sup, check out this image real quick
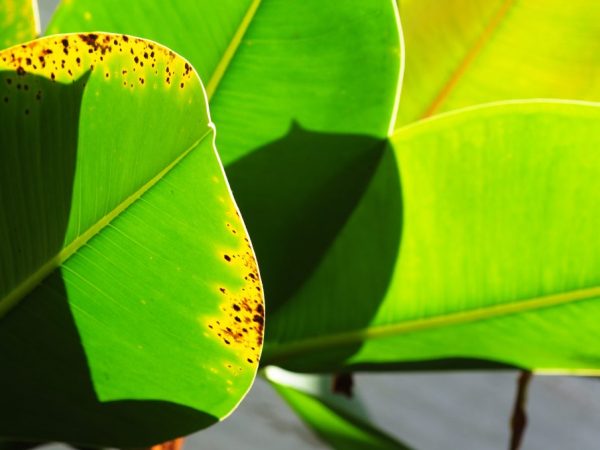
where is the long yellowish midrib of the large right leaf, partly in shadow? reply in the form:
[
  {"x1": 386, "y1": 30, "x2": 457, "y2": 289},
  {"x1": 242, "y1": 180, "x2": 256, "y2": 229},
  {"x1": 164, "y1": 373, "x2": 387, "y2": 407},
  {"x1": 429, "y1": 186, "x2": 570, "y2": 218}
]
[{"x1": 263, "y1": 286, "x2": 600, "y2": 364}]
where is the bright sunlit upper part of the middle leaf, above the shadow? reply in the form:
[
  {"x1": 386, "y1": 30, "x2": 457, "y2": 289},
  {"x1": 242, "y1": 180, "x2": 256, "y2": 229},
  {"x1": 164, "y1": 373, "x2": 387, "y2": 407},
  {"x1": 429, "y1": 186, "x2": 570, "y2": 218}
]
[{"x1": 48, "y1": 0, "x2": 401, "y2": 162}]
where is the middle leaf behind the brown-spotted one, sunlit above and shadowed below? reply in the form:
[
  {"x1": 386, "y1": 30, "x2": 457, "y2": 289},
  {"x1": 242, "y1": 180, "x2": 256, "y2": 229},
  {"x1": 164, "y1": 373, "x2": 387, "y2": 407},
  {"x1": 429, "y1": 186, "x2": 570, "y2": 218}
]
[{"x1": 49, "y1": 0, "x2": 401, "y2": 344}]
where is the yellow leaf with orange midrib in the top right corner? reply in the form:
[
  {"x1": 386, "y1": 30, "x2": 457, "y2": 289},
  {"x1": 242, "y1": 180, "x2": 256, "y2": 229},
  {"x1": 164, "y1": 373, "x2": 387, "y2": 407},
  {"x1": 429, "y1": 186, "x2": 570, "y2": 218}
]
[{"x1": 397, "y1": 0, "x2": 600, "y2": 126}]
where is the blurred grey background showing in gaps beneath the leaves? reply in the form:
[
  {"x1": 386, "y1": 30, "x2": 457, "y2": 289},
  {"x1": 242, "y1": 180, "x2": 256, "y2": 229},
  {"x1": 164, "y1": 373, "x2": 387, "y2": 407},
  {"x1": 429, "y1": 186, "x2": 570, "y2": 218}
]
[{"x1": 39, "y1": 0, "x2": 600, "y2": 450}]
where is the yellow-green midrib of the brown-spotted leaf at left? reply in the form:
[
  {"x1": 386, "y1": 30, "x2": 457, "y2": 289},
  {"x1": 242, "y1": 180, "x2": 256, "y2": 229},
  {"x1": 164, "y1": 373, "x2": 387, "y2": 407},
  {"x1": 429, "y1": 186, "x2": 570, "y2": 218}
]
[{"x1": 0, "y1": 125, "x2": 213, "y2": 318}]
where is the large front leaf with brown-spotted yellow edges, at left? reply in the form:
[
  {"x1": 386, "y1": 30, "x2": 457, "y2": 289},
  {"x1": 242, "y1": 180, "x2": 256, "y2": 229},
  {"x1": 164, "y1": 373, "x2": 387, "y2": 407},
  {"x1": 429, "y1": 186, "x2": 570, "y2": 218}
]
[{"x1": 0, "y1": 34, "x2": 263, "y2": 447}]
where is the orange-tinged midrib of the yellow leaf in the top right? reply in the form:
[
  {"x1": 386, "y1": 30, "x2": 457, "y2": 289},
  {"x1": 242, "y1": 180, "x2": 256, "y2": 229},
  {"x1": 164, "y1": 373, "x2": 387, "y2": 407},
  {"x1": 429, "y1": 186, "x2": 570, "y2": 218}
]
[{"x1": 421, "y1": 0, "x2": 515, "y2": 119}]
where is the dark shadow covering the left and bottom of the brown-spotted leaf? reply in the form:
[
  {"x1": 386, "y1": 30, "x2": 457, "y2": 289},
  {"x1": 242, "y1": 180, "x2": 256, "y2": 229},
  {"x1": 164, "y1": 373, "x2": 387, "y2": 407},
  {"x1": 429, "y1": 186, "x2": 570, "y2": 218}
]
[{"x1": 0, "y1": 72, "x2": 217, "y2": 447}]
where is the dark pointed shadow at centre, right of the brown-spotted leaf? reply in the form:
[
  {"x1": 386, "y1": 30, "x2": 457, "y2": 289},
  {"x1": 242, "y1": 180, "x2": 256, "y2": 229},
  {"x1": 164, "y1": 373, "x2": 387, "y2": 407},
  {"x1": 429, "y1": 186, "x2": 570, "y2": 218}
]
[{"x1": 226, "y1": 124, "x2": 402, "y2": 370}]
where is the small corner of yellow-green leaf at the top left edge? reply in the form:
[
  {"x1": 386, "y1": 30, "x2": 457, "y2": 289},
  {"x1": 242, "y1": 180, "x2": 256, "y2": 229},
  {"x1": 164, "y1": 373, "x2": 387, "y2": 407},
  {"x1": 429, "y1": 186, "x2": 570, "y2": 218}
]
[{"x1": 0, "y1": 0, "x2": 40, "y2": 50}]
